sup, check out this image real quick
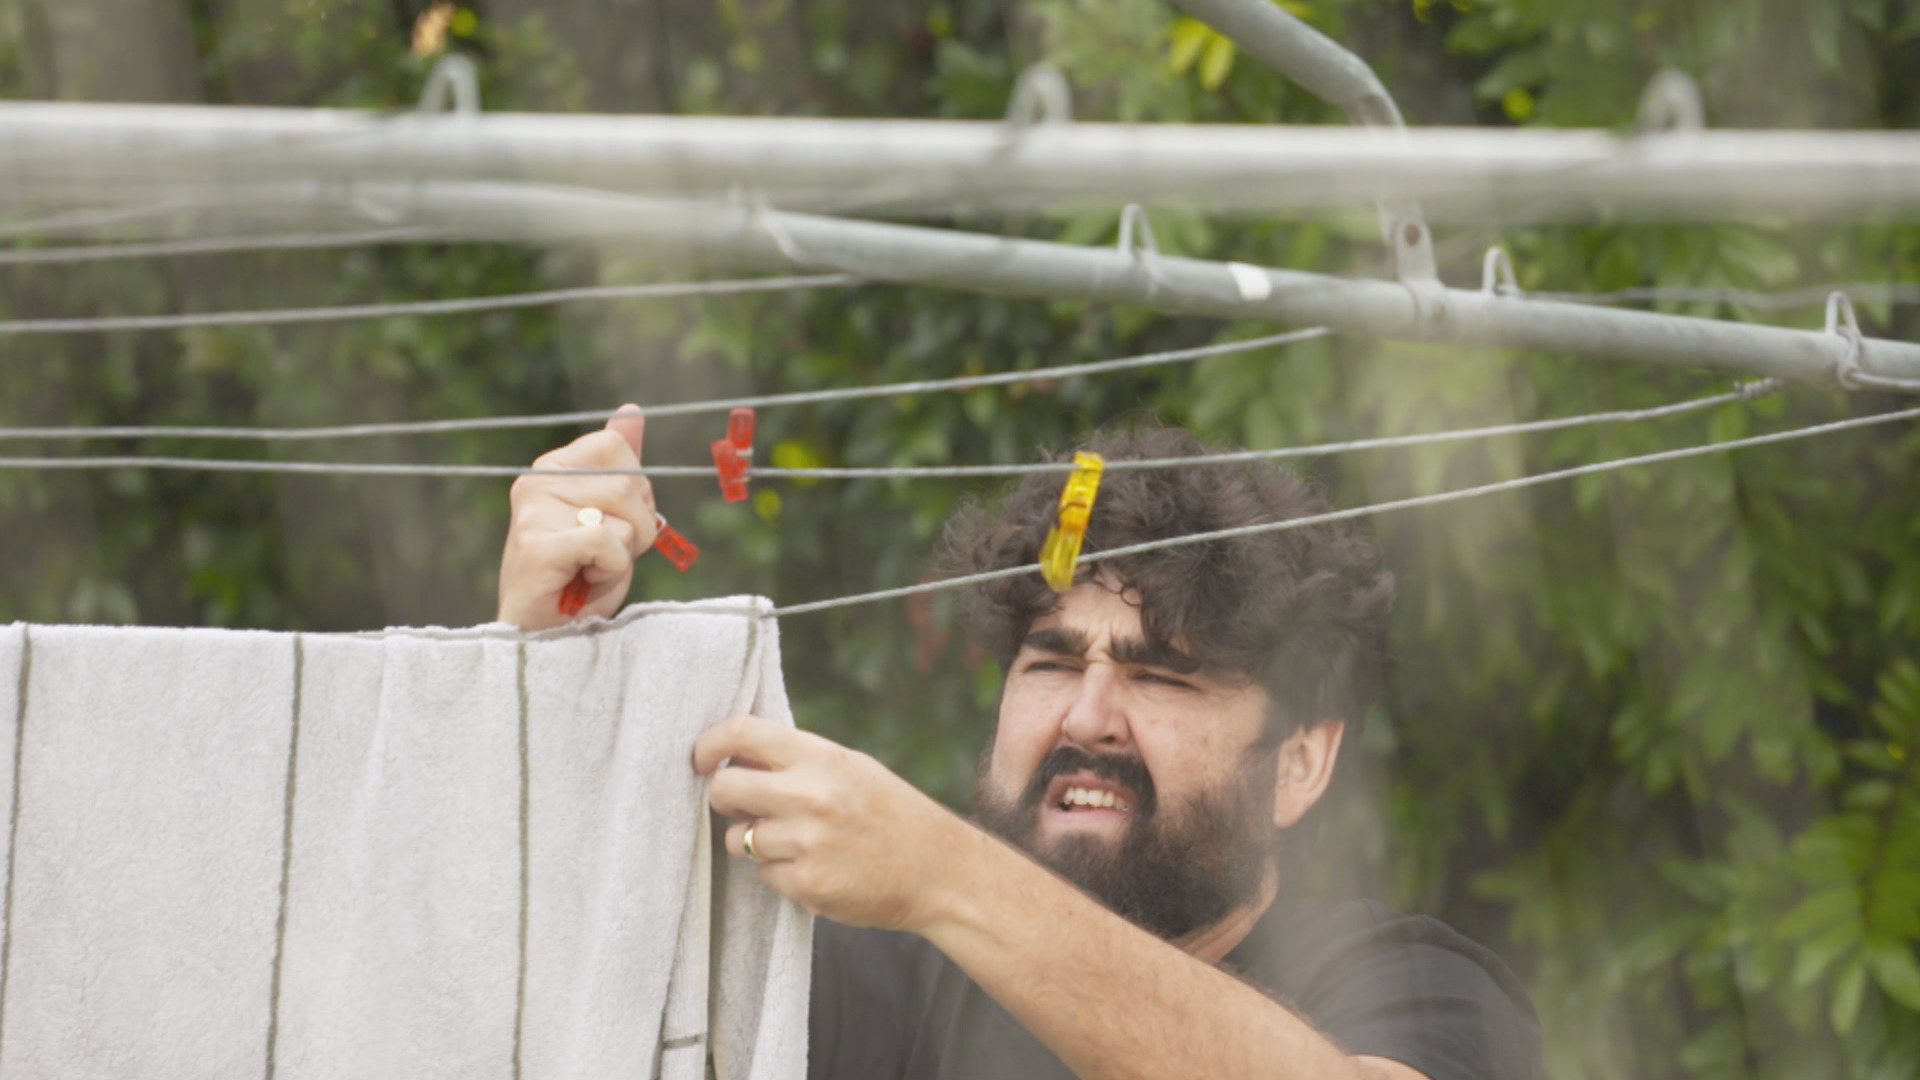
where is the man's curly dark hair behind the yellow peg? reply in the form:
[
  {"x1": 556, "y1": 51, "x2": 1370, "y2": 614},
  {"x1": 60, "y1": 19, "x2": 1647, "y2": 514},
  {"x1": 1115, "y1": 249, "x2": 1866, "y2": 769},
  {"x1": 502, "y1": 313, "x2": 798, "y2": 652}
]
[{"x1": 941, "y1": 419, "x2": 1394, "y2": 746}]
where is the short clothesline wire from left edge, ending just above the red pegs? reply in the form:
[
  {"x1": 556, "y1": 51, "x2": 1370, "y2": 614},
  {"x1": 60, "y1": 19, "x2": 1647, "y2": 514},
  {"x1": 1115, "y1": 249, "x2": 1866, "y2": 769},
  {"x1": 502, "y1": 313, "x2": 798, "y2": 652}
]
[{"x1": 0, "y1": 273, "x2": 860, "y2": 336}]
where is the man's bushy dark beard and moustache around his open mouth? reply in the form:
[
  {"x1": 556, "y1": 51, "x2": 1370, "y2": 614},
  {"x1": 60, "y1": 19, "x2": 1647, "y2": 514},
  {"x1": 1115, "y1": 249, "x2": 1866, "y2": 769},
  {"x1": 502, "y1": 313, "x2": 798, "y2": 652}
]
[{"x1": 973, "y1": 746, "x2": 1279, "y2": 940}]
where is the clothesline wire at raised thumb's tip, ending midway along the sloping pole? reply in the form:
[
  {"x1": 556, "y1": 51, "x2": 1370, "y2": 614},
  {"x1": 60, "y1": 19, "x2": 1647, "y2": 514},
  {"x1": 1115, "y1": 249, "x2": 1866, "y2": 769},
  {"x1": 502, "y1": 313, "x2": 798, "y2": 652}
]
[{"x1": 0, "y1": 326, "x2": 1332, "y2": 440}]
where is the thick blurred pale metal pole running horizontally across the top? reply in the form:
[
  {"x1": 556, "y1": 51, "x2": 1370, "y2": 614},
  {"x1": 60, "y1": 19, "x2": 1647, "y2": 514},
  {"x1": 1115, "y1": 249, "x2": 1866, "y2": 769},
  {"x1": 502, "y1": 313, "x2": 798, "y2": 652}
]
[{"x1": 0, "y1": 105, "x2": 1920, "y2": 222}]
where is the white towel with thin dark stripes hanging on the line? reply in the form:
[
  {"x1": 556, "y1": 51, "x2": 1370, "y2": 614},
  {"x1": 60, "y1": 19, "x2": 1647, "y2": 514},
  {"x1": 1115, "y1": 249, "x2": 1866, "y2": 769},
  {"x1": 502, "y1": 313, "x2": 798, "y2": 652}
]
[{"x1": 0, "y1": 598, "x2": 812, "y2": 1080}]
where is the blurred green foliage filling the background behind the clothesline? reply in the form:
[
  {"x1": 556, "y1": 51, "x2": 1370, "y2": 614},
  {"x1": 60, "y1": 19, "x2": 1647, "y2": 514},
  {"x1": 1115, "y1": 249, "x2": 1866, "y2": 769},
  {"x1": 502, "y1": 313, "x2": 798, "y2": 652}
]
[{"x1": 0, "y1": 0, "x2": 1920, "y2": 1080}]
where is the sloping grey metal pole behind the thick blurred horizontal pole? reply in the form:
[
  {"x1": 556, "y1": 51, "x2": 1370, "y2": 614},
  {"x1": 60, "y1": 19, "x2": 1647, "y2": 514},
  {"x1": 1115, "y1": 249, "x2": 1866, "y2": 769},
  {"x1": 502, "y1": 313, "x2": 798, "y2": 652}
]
[{"x1": 361, "y1": 184, "x2": 1920, "y2": 386}]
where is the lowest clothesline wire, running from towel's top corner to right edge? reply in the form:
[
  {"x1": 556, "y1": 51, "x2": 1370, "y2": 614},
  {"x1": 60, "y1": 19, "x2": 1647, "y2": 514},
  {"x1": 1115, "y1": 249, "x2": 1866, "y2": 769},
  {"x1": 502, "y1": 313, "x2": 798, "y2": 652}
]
[{"x1": 770, "y1": 399, "x2": 1920, "y2": 617}]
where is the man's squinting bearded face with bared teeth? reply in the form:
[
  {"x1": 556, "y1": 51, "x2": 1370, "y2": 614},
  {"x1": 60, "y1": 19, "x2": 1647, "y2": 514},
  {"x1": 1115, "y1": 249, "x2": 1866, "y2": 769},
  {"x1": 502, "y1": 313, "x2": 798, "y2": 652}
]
[{"x1": 975, "y1": 578, "x2": 1275, "y2": 938}]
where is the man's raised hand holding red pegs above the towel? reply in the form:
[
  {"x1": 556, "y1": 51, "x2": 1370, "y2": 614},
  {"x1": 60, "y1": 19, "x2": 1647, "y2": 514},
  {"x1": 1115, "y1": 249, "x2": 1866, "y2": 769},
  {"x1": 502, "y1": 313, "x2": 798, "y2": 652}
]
[{"x1": 497, "y1": 405, "x2": 659, "y2": 630}]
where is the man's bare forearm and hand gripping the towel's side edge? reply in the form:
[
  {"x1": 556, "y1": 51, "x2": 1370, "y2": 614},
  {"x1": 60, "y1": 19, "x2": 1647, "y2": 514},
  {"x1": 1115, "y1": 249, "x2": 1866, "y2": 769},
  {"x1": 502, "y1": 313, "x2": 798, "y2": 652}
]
[{"x1": 695, "y1": 717, "x2": 1423, "y2": 1080}]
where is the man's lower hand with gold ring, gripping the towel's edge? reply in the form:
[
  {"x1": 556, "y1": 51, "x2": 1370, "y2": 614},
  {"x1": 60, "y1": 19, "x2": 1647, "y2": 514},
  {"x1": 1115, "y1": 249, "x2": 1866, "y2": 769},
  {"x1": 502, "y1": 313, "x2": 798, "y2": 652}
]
[{"x1": 693, "y1": 717, "x2": 975, "y2": 932}]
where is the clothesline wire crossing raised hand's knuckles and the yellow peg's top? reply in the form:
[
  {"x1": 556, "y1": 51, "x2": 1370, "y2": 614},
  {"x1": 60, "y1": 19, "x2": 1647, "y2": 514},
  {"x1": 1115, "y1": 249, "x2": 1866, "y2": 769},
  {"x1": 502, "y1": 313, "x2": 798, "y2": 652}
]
[{"x1": 0, "y1": 379, "x2": 1780, "y2": 480}]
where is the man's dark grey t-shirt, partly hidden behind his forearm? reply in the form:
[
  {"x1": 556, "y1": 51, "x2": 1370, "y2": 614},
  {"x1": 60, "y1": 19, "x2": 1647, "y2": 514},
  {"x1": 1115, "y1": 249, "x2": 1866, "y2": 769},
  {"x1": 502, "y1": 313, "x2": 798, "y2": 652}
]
[{"x1": 806, "y1": 899, "x2": 1540, "y2": 1080}]
